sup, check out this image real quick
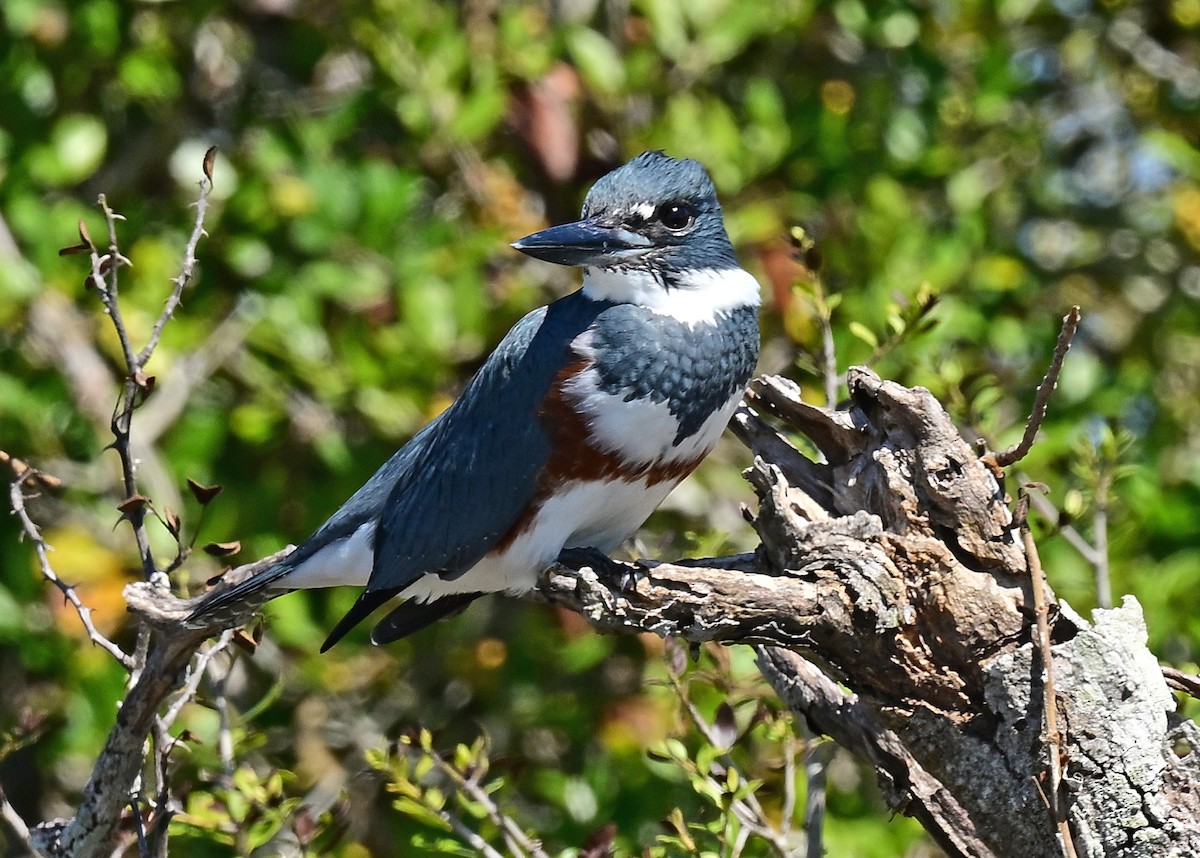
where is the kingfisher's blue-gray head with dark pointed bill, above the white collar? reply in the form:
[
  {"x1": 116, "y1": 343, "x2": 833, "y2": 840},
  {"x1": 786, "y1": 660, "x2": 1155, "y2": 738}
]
[{"x1": 512, "y1": 151, "x2": 738, "y2": 277}]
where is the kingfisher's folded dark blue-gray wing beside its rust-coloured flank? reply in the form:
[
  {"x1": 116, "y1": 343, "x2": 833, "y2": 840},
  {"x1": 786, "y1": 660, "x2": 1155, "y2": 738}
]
[{"x1": 364, "y1": 293, "x2": 608, "y2": 593}]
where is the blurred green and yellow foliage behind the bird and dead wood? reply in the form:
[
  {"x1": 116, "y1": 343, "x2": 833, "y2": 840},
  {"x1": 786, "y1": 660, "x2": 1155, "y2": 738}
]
[{"x1": 0, "y1": 0, "x2": 1200, "y2": 857}]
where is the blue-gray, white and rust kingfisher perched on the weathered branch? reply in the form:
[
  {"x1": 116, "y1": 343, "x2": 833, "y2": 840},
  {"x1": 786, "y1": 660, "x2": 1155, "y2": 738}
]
[{"x1": 190, "y1": 151, "x2": 760, "y2": 652}]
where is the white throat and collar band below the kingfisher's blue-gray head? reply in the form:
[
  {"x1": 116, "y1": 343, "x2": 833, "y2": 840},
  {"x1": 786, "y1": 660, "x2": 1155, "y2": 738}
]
[{"x1": 583, "y1": 268, "x2": 761, "y2": 324}]
